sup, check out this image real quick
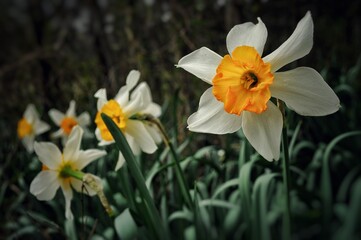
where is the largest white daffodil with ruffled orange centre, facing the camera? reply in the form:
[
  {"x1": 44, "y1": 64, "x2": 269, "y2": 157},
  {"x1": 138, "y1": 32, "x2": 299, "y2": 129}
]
[{"x1": 177, "y1": 12, "x2": 340, "y2": 161}]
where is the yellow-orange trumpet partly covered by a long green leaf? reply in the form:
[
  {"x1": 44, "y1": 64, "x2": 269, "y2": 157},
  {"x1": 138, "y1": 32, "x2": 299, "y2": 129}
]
[{"x1": 95, "y1": 100, "x2": 127, "y2": 141}]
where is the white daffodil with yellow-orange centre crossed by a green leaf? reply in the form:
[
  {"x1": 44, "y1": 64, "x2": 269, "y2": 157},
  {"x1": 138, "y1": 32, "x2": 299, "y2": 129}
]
[{"x1": 94, "y1": 70, "x2": 161, "y2": 170}]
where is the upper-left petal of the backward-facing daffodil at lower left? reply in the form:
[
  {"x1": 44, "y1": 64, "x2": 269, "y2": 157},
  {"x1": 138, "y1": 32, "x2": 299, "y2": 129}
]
[{"x1": 34, "y1": 142, "x2": 62, "y2": 169}]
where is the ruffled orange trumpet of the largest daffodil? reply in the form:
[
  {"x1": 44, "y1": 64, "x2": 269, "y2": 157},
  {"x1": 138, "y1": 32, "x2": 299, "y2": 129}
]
[{"x1": 212, "y1": 46, "x2": 274, "y2": 115}]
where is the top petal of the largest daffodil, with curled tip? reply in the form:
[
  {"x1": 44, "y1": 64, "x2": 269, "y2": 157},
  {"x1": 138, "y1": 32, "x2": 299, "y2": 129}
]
[{"x1": 226, "y1": 18, "x2": 267, "y2": 56}]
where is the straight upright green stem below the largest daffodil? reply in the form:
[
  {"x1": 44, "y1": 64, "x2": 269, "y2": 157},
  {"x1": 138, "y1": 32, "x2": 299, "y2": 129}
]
[{"x1": 278, "y1": 101, "x2": 291, "y2": 240}]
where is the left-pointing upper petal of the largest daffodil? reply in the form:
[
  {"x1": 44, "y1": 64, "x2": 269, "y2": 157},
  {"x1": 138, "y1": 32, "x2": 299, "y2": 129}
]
[{"x1": 176, "y1": 47, "x2": 222, "y2": 84}]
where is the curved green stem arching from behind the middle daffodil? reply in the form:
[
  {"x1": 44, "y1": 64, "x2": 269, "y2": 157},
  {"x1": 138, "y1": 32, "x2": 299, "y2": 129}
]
[{"x1": 145, "y1": 115, "x2": 194, "y2": 210}]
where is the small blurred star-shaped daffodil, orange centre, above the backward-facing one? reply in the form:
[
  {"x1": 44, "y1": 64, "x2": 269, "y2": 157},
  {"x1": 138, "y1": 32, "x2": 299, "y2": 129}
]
[{"x1": 49, "y1": 100, "x2": 90, "y2": 144}]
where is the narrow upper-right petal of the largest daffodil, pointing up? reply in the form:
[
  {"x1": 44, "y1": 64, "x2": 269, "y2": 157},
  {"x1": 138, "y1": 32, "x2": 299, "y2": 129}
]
[{"x1": 263, "y1": 12, "x2": 313, "y2": 72}]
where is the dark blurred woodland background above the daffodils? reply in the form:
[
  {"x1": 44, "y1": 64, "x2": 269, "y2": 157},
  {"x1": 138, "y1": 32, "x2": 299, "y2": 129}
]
[{"x1": 0, "y1": 0, "x2": 361, "y2": 133}]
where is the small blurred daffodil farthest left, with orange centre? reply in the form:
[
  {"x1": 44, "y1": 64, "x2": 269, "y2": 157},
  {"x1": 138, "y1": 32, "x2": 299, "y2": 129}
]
[{"x1": 17, "y1": 104, "x2": 50, "y2": 153}]
